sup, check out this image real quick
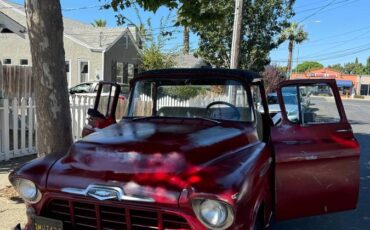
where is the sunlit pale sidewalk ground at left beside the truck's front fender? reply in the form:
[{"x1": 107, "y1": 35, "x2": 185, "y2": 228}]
[{"x1": 0, "y1": 155, "x2": 36, "y2": 230}]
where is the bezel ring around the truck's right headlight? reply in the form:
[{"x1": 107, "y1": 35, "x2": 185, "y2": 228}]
[{"x1": 191, "y1": 198, "x2": 234, "y2": 230}]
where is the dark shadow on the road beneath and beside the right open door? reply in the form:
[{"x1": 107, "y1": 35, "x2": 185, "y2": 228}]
[{"x1": 269, "y1": 133, "x2": 370, "y2": 230}]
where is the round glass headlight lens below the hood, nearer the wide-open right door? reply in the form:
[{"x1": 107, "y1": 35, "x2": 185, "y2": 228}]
[{"x1": 199, "y1": 200, "x2": 227, "y2": 226}]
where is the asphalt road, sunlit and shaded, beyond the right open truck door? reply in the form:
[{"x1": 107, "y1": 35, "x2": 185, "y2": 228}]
[{"x1": 269, "y1": 100, "x2": 370, "y2": 230}]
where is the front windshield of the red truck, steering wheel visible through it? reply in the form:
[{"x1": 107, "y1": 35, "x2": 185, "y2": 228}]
[{"x1": 128, "y1": 78, "x2": 253, "y2": 121}]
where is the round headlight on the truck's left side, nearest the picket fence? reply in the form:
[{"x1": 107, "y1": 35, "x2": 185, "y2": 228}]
[{"x1": 13, "y1": 179, "x2": 41, "y2": 204}]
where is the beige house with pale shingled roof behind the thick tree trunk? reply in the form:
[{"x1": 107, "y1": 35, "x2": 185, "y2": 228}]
[{"x1": 0, "y1": 0, "x2": 141, "y2": 86}]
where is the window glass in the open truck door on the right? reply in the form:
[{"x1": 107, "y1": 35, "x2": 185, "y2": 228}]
[{"x1": 282, "y1": 84, "x2": 340, "y2": 124}]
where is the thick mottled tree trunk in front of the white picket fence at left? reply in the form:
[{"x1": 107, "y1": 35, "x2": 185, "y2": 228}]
[{"x1": 26, "y1": 0, "x2": 73, "y2": 156}]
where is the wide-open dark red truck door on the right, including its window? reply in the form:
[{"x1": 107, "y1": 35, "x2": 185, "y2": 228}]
[{"x1": 271, "y1": 79, "x2": 360, "y2": 220}]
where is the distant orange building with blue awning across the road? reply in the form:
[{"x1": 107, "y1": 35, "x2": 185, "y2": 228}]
[{"x1": 291, "y1": 68, "x2": 360, "y2": 95}]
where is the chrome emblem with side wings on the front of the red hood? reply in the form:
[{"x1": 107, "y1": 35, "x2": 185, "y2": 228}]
[{"x1": 61, "y1": 184, "x2": 155, "y2": 202}]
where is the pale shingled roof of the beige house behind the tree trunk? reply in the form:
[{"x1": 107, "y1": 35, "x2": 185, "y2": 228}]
[{"x1": 0, "y1": 0, "x2": 138, "y2": 51}]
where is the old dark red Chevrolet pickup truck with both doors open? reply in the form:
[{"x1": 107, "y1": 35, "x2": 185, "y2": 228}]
[{"x1": 9, "y1": 69, "x2": 360, "y2": 230}]
